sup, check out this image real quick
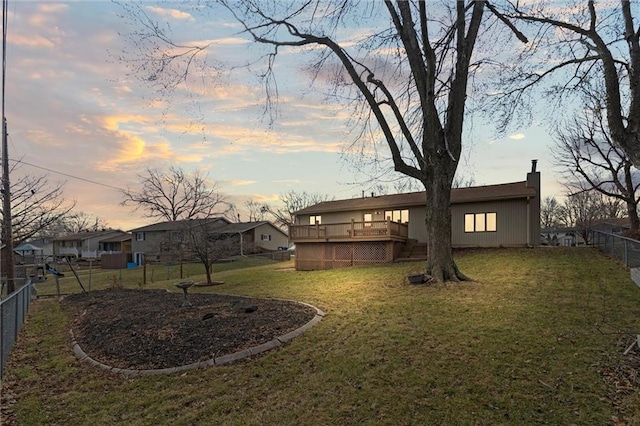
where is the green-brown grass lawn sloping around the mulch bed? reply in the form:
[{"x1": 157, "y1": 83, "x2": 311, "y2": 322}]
[{"x1": 3, "y1": 248, "x2": 640, "y2": 425}]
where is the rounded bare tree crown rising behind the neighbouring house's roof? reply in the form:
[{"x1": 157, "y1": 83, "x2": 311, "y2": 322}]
[{"x1": 122, "y1": 166, "x2": 230, "y2": 221}]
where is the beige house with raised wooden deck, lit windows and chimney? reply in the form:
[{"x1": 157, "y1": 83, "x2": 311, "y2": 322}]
[{"x1": 289, "y1": 160, "x2": 540, "y2": 270}]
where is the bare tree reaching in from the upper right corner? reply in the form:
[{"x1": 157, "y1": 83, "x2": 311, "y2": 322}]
[{"x1": 493, "y1": 0, "x2": 640, "y2": 167}]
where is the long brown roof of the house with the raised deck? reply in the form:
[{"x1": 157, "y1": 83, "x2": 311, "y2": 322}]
[{"x1": 295, "y1": 181, "x2": 536, "y2": 215}]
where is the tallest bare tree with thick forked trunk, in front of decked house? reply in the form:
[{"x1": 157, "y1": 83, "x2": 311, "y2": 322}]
[{"x1": 119, "y1": 0, "x2": 524, "y2": 281}]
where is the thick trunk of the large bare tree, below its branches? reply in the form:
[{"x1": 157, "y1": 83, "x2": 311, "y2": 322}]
[{"x1": 423, "y1": 166, "x2": 469, "y2": 282}]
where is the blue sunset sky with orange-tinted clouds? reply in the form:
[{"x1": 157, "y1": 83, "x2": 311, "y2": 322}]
[{"x1": 5, "y1": 0, "x2": 564, "y2": 230}]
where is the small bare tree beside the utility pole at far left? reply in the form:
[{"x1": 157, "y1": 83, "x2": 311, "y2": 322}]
[{"x1": 0, "y1": 169, "x2": 75, "y2": 244}]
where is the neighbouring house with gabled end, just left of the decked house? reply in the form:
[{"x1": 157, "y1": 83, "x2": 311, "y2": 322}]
[{"x1": 131, "y1": 217, "x2": 289, "y2": 265}]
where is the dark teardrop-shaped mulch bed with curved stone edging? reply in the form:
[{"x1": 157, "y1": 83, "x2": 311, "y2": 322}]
[{"x1": 62, "y1": 289, "x2": 316, "y2": 369}]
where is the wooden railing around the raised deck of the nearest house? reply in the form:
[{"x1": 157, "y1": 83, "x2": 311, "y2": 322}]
[{"x1": 289, "y1": 220, "x2": 409, "y2": 242}]
